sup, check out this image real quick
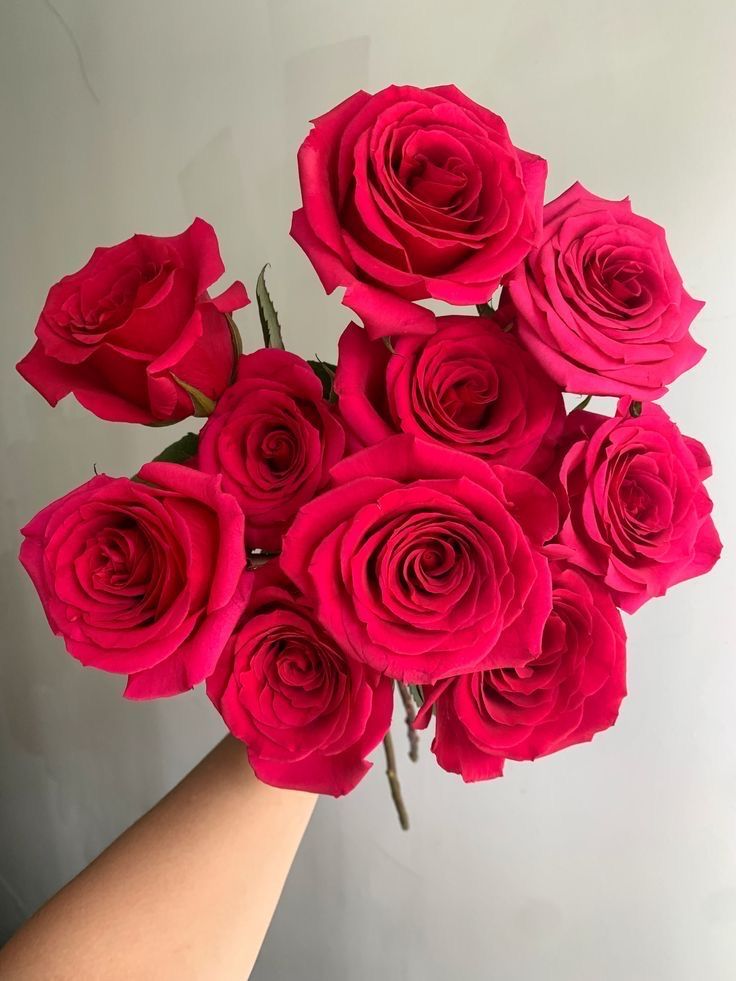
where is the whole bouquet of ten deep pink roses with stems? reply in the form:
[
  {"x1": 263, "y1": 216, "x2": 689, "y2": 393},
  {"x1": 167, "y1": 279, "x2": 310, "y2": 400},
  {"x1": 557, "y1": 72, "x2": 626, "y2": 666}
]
[{"x1": 18, "y1": 86, "x2": 721, "y2": 825}]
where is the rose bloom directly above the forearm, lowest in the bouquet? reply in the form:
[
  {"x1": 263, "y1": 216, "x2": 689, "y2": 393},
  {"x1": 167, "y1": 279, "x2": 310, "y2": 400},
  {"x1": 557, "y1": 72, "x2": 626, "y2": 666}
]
[{"x1": 207, "y1": 561, "x2": 393, "y2": 797}]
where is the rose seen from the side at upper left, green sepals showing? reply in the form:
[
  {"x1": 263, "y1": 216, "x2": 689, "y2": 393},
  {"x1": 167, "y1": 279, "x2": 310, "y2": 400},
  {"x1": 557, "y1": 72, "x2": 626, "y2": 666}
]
[{"x1": 18, "y1": 218, "x2": 248, "y2": 424}]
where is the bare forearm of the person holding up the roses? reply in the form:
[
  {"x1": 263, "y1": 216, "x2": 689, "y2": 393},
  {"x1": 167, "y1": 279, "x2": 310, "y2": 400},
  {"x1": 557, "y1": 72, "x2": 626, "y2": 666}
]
[{"x1": 0, "y1": 736, "x2": 317, "y2": 981}]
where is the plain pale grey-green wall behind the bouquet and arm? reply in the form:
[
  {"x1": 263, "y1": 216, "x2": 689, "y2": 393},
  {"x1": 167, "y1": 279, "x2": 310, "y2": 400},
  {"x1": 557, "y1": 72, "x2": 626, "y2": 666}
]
[{"x1": 0, "y1": 0, "x2": 736, "y2": 981}]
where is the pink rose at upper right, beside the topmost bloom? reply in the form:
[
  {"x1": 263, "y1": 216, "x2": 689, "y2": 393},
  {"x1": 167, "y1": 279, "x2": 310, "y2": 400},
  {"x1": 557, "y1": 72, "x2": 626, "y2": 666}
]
[{"x1": 501, "y1": 184, "x2": 705, "y2": 399}]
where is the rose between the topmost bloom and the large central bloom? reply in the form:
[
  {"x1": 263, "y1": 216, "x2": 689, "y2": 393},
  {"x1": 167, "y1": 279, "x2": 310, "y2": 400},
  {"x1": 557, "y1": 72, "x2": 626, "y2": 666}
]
[{"x1": 334, "y1": 317, "x2": 565, "y2": 467}]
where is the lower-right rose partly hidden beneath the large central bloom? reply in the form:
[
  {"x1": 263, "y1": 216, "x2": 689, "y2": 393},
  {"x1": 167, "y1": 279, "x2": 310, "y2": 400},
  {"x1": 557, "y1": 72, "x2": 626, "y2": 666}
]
[{"x1": 416, "y1": 563, "x2": 626, "y2": 782}]
